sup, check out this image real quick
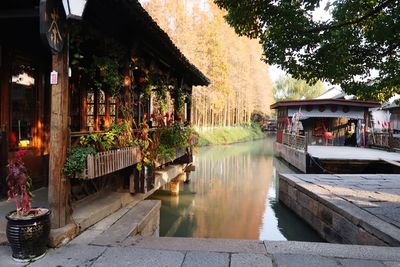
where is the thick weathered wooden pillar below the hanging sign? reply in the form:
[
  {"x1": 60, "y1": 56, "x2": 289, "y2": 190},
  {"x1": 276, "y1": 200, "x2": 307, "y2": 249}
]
[{"x1": 48, "y1": 48, "x2": 71, "y2": 229}]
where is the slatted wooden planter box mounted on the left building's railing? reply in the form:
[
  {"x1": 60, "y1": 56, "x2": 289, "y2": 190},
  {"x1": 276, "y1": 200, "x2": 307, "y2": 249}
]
[{"x1": 75, "y1": 147, "x2": 140, "y2": 179}]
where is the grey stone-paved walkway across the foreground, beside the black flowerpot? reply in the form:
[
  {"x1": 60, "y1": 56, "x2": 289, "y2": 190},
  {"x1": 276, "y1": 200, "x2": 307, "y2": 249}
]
[{"x1": 0, "y1": 236, "x2": 400, "y2": 267}]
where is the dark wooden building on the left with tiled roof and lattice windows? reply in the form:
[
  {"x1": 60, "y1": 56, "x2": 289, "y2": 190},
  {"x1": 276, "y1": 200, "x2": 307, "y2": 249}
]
[{"x1": 0, "y1": 0, "x2": 209, "y2": 234}]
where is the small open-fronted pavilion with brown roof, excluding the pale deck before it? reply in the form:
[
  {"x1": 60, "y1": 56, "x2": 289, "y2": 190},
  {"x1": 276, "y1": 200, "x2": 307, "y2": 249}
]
[{"x1": 271, "y1": 99, "x2": 380, "y2": 146}]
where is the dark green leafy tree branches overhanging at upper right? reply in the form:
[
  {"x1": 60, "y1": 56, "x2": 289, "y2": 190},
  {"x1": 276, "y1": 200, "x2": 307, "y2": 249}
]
[{"x1": 214, "y1": 0, "x2": 400, "y2": 101}]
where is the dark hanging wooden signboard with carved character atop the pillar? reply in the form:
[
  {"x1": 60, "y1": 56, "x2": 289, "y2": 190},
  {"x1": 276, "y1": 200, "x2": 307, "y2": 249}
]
[{"x1": 40, "y1": 0, "x2": 66, "y2": 53}]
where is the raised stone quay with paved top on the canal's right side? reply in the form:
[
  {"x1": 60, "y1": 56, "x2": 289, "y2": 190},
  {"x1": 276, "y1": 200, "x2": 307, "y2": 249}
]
[{"x1": 279, "y1": 174, "x2": 400, "y2": 246}]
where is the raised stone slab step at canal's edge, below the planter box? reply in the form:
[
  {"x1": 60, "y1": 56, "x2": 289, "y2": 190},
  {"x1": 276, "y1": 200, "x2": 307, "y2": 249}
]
[{"x1": 90, "y1": 200, "x2": 161, "y2": 246}]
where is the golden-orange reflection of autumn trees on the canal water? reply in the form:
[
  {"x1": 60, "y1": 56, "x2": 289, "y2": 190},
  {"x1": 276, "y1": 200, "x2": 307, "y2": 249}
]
[{"x1": 189, "y1": 141, "x2": 272, "y2": 239}]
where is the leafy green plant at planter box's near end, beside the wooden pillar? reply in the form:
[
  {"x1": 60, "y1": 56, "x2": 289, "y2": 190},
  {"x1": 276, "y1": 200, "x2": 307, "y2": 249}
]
[{"x1": 63, "y1": 146, "x2": 96, "y2": 177}]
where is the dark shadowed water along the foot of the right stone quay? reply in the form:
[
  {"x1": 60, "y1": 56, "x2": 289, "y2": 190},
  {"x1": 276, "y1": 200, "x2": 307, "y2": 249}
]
[{"x1": 270, "y1": 200, "x2": 324, "y2": 242}]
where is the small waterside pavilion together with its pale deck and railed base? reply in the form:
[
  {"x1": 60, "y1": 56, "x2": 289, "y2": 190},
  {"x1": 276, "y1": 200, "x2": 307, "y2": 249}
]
[{"x1": 271, "y1": 99, "x2": 400, "y2": 173}]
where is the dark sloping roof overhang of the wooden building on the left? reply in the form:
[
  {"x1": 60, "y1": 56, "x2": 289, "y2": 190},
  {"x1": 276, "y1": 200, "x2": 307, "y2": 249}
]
[{"x1": 83, "y1": 0, "x2": 210, "y2": 86}]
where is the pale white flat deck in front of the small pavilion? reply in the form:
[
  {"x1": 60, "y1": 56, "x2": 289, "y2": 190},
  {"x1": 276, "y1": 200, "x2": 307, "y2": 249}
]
[{"x1": 307, "y1": 146, "x2": 400, "y2": 161}]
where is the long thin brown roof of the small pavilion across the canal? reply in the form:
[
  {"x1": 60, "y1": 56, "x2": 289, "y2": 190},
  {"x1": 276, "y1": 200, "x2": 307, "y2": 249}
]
[{"x1": 271, "y1": 99, "x2": 381, "y2": 109}]
